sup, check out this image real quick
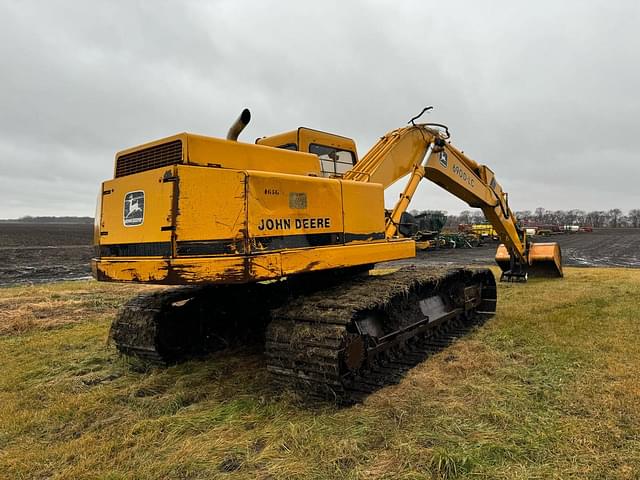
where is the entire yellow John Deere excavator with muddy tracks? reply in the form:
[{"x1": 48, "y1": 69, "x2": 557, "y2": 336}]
[{"x1": 92, "y1": 109, "x2": 562, "y2": 402}]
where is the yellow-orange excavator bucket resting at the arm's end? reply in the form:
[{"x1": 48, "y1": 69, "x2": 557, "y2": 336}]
[{"x1": 496, "y1": 242, "x2": 563, "y2": 281}]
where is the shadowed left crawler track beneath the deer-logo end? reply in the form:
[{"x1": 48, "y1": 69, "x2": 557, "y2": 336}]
[{"x1": 110, "y1": 284, "x2": 286, "y2": 364}]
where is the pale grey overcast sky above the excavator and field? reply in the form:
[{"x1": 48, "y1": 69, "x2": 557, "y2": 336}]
[{"x1": 0, "y1": 0, "x2": 640, "y2": 218}]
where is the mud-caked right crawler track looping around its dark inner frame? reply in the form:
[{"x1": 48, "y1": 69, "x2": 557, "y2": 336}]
[{"x1": 265, "y1": 268, "x2": 496, "y2": 404}]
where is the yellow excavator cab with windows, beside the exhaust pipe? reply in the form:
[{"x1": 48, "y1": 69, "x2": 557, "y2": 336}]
[{"x1": 256, "y1": 127, "x2": 358, "y2": 178}]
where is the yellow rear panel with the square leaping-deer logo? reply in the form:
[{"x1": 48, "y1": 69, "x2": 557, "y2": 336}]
[{"x1": 100, "y1": 167, "x2": 173, "y2": 245}]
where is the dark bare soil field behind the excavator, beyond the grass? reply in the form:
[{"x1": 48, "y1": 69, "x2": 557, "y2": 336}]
[{"x1": 0, "y1": 223, "x2": 640, "y2": 286}]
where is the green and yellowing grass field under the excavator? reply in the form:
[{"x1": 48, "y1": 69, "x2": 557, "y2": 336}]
[{"x1": 0, "y1": 268, "x2": 640, "y2": 479}]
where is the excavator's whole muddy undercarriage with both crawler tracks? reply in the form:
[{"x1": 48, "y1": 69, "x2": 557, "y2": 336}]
[{"x1": 111, "y1": 267, "x2": 496, "y2": 403}]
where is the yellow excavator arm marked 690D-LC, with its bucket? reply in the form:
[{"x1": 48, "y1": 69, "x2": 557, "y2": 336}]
[{"x1": 344, "y1": 124, "x2": 562, "y2": 280}]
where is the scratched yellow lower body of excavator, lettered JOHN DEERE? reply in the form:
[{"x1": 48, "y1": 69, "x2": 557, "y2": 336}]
[{"x1": 93, "y1": 164, "x2": 415, "y2": 285}]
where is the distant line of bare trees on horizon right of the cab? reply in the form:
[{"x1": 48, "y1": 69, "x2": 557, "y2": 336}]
[{"x1": 411, "y1": 207, "x2": 640, "y2": 228}]
